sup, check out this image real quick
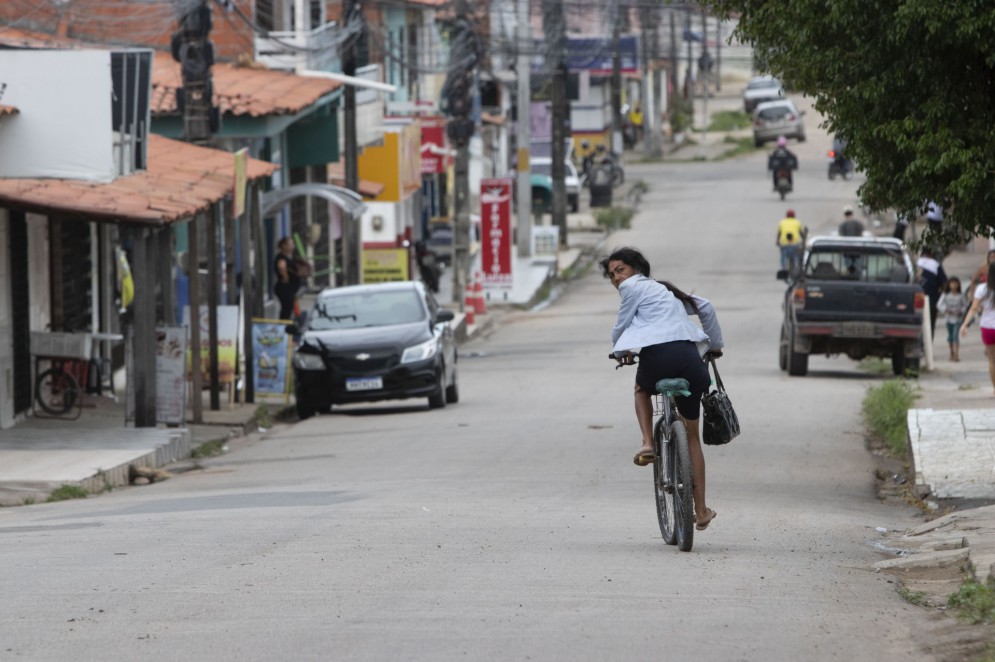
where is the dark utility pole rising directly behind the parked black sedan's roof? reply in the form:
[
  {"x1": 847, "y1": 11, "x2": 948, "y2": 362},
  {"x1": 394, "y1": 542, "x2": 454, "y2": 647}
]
[{"x1": 342, "y1": 0, "x2": 363, "y2": 285}]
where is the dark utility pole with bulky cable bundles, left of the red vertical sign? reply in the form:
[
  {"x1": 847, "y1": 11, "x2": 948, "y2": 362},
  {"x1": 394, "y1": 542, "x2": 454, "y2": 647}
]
[{"x1": 442, "y1": 0, "x2": 480, "y2": 310}]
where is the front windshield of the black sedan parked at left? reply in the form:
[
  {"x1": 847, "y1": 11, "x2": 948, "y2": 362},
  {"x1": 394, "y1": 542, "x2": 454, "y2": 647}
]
[{"x1": 308, "y1": 290, "x2": 425, "y2": 331}]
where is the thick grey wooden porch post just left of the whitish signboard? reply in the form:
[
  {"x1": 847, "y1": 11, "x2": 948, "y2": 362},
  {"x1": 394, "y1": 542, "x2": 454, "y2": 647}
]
[{"x1": 131, "y1": 229, "x2": 158, "y2": 428}]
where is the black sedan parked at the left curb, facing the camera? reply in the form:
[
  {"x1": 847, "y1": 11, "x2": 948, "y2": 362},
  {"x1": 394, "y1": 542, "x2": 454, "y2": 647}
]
[{"x1": 294, "y1": 281, "x2": 459, "y2": 419}]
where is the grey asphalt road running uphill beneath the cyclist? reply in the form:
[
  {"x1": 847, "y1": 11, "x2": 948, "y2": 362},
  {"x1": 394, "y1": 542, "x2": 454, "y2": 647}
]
[{"x1": 0, "y1": 101, "x2": 944, "y2": 661}]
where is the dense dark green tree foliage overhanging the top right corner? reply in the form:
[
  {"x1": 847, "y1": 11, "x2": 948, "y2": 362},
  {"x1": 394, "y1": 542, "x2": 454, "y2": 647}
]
[{"x1": 706, "y1": 0, "x2": 995, "y2": 244}]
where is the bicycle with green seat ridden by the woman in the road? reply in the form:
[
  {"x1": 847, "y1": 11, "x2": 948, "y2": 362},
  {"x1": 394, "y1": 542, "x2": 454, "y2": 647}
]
[{"x1": 608, "y1": 354, "x2": 694, "y2": 552}]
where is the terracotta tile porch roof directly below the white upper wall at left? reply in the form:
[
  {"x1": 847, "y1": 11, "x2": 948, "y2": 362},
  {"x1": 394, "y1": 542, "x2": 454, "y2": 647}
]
[{"x1": 0, "y1": 135, "x2": 277, "y2": 225}]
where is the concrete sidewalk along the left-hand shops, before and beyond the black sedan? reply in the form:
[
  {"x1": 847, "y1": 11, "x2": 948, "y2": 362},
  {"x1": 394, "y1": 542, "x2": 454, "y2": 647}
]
[{"x1": 0, "y1": 213, "x2": 604, "y2": 506}]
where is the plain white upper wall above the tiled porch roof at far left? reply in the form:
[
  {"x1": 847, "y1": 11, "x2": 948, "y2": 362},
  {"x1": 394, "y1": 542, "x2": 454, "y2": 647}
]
[{"x1": 0, "y1": 50, "x2": 115, "y2": 182}]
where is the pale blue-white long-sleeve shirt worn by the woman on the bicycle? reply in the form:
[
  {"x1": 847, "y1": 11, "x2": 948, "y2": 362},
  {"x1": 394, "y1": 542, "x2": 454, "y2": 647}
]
[{"x1": 612, "y1": 274, "x2": 723, "y2": 354}]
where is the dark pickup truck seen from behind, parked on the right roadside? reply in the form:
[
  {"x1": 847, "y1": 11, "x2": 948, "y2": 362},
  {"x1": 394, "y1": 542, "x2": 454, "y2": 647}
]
[{"x1": 778, "y1": 237, "x2": 926, "y2": 376}]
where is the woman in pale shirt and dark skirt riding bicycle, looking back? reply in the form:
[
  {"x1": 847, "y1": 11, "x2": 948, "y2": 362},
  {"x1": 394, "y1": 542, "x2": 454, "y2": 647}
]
[{"x1": 601, "y1": 248, "x2": 723, "y2": 530}]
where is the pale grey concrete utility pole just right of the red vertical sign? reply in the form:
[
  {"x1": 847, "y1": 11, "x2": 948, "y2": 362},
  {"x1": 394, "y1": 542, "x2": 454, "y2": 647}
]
[{"x1": 515, "y1": 0, "x2": 532, "y2": 257}]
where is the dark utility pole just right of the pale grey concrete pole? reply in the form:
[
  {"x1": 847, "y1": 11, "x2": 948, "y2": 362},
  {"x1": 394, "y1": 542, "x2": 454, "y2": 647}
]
[{"x1": 543, "y1": 0, "x2": 570, "y2": 246}]
